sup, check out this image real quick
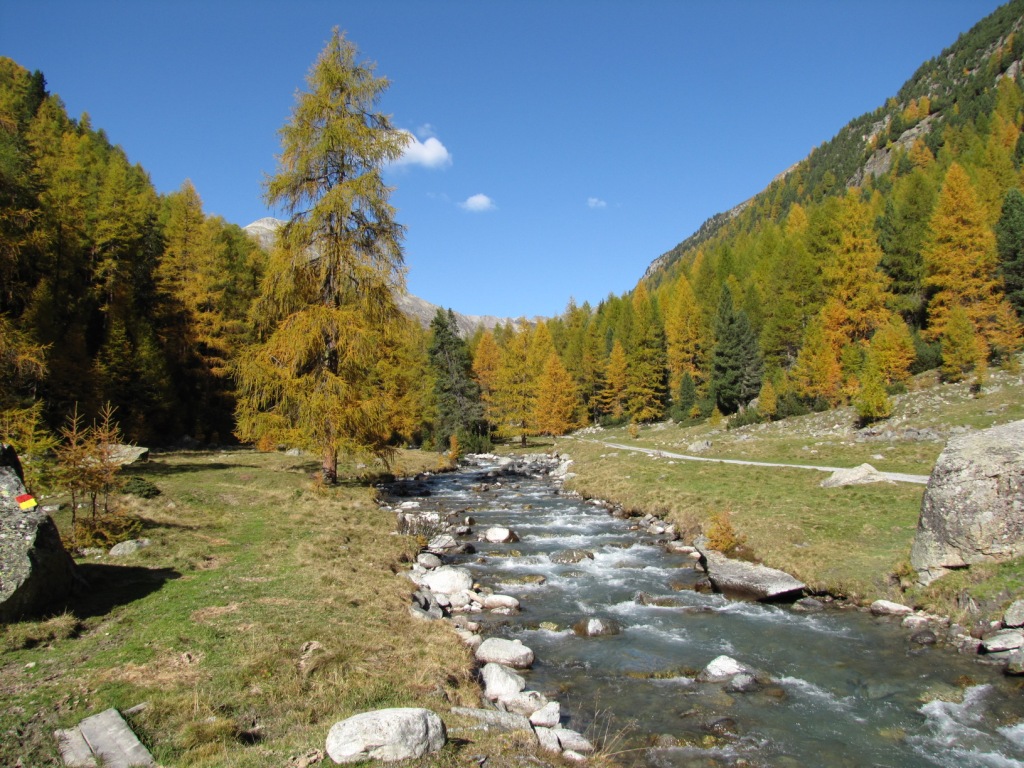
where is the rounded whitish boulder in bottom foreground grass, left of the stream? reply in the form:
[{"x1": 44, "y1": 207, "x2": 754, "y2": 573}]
[{"x1": 327, "y1": 708, "x2": 447, "y2": 763}]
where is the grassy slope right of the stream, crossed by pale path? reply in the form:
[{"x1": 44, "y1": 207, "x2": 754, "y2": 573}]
[{"x1": 553, "y1": 372, "x2": 1024, "y2": 618}]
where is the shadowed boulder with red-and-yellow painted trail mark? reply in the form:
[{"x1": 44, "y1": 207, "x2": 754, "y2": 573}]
[{"x1": 0, "y1": 466, "x2": 75, "y2": 622}]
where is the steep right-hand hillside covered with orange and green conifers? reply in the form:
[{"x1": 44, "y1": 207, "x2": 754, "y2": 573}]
[{"x1": 506, "y1": 0, "x2": 1024, "y2": 434}]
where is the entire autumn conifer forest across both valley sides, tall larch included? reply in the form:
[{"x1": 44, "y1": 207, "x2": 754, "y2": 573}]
[{"x1": 6, "y1": 0, "x2": 1024, "y2": 473}]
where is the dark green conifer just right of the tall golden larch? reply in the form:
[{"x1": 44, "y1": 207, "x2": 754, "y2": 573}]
[{"x1": 427, "y1": 309, "x2": 483, "y2": 452}]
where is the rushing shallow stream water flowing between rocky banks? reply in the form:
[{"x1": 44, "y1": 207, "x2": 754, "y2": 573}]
[{"x1": 391, "y1": 456, "x2": 1024, "y2": 768}]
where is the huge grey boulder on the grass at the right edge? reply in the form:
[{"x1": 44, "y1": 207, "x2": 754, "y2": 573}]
[{"x1": 910, "y1": 421, "x2": 1024, "y2": 584}]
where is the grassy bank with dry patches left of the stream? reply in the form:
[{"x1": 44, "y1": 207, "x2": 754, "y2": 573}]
[{"x1": 0, "y1": 451, "x2": 569, "y2": 768}]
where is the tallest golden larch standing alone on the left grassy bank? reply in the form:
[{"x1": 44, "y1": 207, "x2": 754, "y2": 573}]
[{"x1": 236, "y1": 34, "x2": 409, "y2": 483}]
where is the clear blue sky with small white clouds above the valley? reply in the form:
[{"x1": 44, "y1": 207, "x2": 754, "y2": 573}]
[{"x1": 0, "y1": 0, "x2": 1000, "y2": 316}]
